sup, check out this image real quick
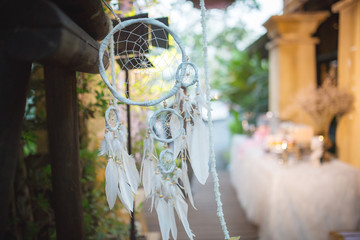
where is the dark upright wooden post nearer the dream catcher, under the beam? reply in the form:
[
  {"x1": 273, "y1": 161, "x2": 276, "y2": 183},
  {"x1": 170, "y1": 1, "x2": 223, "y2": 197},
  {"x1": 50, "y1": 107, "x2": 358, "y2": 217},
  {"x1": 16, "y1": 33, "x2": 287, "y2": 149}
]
[{"x1": 45, "y1": 66, "x2": 84, "y2": 240}]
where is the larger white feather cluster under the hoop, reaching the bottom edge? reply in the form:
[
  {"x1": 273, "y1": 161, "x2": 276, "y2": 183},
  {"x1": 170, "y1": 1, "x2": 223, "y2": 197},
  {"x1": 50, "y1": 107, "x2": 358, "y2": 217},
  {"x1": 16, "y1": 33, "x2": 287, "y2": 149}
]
[{"x1": 140, "y1": 84, "x2": 209, "y2": 239}]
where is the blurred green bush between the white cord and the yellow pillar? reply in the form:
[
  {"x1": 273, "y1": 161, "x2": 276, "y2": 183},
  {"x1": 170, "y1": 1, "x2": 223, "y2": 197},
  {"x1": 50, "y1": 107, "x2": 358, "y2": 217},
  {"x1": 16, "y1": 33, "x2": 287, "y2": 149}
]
[{"x1": 213, "y1": 51, "x2": 268, "y2": 133}]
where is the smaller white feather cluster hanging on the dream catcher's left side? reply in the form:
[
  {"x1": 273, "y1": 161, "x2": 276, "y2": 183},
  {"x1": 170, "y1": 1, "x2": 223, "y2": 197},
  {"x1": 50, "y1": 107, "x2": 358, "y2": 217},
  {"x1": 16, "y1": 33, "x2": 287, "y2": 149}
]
[{"x1": 99, "y1": 112, "x2": 140, "y2": 212}]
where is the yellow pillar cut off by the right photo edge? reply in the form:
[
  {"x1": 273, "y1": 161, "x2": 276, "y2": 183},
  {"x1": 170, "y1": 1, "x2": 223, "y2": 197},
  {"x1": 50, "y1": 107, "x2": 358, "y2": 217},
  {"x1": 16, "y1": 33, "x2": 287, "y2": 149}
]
[{"x1": 332, "y1": 0, "x2": 360, "y2": 168}]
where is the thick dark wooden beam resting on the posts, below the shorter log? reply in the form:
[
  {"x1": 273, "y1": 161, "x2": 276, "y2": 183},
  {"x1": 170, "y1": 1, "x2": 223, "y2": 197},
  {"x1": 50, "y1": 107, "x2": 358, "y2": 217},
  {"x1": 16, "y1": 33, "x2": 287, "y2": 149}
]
[{"x1": 4, "y1": 0, "x2": 108, "y2": 73}]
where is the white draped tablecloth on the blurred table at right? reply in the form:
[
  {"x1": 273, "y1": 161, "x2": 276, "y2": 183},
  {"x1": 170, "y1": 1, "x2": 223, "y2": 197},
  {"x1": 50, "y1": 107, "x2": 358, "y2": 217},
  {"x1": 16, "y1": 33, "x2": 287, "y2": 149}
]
[{"x1": 230, "y1": 136, "x2": 360, "y2": 240}]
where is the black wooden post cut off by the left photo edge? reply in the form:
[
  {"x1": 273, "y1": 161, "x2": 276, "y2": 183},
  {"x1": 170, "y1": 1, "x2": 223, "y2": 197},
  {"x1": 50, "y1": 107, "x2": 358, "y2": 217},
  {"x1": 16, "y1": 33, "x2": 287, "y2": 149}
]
[{"x1": 0, "y1": 48, "x2": 31, "y2": 239}]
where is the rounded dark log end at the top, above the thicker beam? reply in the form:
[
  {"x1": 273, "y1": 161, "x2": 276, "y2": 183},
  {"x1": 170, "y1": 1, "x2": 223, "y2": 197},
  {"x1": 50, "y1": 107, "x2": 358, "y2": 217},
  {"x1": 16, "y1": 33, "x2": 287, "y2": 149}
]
[{"x1": 52, "y1": 0, "x2": 109, "y2": 41}]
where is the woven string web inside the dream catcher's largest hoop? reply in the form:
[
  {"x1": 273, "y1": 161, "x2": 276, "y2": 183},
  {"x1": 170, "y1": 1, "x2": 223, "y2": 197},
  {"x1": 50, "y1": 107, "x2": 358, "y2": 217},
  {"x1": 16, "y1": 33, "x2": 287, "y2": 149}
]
[{"x1": 105, "y1": 22, "x2": 182, "y2": 102}]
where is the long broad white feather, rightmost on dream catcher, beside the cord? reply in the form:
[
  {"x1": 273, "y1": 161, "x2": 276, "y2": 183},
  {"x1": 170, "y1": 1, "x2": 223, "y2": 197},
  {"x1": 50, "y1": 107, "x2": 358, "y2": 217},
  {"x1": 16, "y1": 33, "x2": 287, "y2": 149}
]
[{"x1": 190, "y1": 117, "x2": 209, "y2": 184}]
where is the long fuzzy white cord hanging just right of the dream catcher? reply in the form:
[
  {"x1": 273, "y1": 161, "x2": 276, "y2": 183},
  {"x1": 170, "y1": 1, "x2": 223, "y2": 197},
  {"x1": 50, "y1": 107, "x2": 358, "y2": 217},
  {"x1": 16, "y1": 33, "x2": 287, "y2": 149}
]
[{"x1": 200, "y1": 0, "x2": 230, "y2": 239}]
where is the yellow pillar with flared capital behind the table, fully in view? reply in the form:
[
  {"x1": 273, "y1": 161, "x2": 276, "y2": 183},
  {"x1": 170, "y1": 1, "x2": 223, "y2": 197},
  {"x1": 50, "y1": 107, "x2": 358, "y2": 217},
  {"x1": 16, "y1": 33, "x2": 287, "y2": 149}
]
[{"x1": 264, "y1": 12, "x2": 329, "y2": 124}]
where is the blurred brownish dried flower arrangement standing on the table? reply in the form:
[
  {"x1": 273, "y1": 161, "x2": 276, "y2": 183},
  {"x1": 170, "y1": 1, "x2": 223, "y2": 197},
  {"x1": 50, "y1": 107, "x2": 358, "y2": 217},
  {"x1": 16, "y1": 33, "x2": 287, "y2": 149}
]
[{"x1": 296, "y1": 76, "x2": 354, "y2": 148}]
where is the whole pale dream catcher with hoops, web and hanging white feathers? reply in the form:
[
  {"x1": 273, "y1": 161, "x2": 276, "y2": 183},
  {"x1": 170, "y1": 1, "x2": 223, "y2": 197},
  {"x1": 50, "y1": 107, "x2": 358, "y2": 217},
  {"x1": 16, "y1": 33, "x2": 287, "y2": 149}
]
[{"x1": 99, "y1": 0, "x2": 236, "y2": 239}]
